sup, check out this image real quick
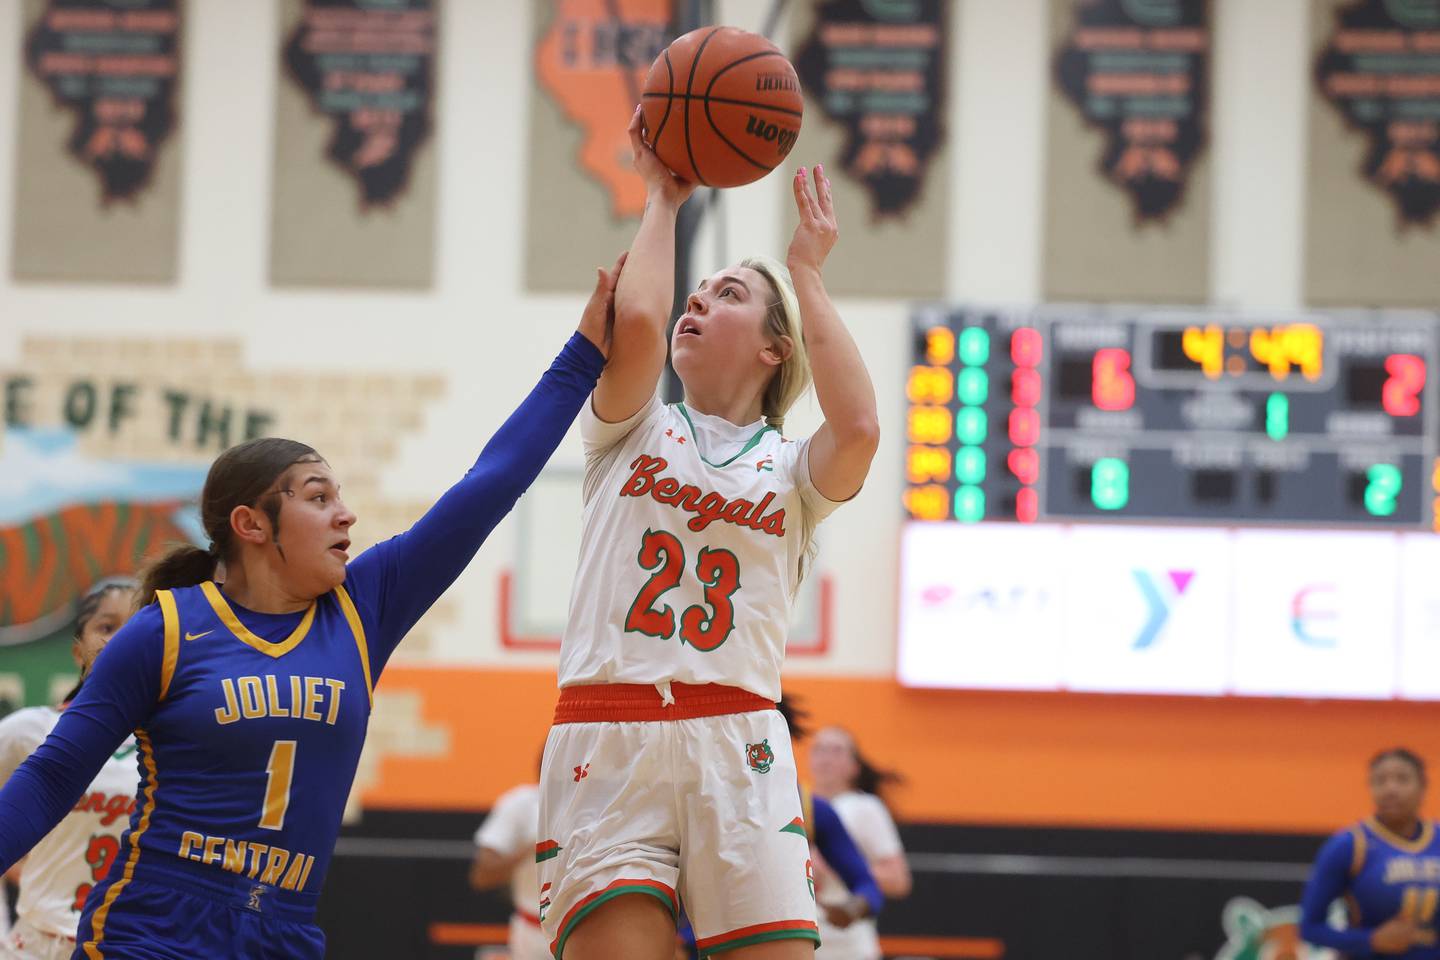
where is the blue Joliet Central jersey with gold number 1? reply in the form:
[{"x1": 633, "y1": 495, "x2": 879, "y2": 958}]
[{"x1": 82, "y1": 581, "x2": 372, "y2": 933}]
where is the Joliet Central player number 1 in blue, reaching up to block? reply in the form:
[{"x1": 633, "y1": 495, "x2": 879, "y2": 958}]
[{"x1": 0, "y1": 258, "x2": 624, "y2": 960}]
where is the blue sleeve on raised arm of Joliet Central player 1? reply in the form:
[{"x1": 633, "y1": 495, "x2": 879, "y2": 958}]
[{"x1": 346, "y1": 334, "x2": 605, "y2": 675}]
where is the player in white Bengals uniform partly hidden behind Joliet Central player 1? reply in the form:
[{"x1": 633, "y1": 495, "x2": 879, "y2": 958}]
[{"x1": 0, "y1": 580, "x2": 140, "y2": 960}]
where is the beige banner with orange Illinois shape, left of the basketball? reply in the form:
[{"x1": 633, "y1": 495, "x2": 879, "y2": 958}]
[{"x1": 524, "y1": 0, "x2": 674, "y2": 292}]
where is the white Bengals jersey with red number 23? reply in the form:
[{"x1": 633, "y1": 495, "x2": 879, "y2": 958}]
[{"x1": 560, "y1": 399, "x2": 838, "y2": 699}]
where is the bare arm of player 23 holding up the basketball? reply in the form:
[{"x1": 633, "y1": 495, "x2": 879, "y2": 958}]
[{"x1": 593, "y1": 107, "x2": 696, "y2": 423}]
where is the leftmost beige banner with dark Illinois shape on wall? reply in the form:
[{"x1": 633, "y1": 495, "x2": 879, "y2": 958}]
[{"x1": 13, "y1": 0, "x2": 181, "y2": 282}]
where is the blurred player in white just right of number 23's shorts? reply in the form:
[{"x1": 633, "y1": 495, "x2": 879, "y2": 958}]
[{"x1": 809, "y1": 727, "x2": 910, "y2": 960}]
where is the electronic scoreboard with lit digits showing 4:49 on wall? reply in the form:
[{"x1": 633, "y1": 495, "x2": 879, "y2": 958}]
[{"x1": 904, "y1": 307, "x2": 1440, "y2": 530}]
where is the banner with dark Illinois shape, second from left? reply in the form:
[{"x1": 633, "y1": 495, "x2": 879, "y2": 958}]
[{"x1": 271, "y1": 0, "x2": 438, "y2": 288}]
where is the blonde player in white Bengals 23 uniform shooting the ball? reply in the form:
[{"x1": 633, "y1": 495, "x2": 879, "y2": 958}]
[{"x1": 536, "y1": 111, "x2": 880, "y2": 960}]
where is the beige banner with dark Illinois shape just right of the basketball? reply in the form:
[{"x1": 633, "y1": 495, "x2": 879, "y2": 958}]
[{"x1": 776, "y1": 0, "x2": 950, "y2": 298}]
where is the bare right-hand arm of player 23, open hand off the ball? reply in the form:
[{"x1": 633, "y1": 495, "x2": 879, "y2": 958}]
[{"x1": 785, "y1": 164, "x2": 880, "y2": 501}]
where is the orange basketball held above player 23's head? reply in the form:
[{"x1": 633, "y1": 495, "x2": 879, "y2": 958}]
[{"x1": 641, "y1": 26, "x2": 805, "y2": 187}]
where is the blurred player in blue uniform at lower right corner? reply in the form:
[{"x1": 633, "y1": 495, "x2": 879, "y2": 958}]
[{"x1": 1300, "y1": 748, "x2": 1440, "y2": 960}]
